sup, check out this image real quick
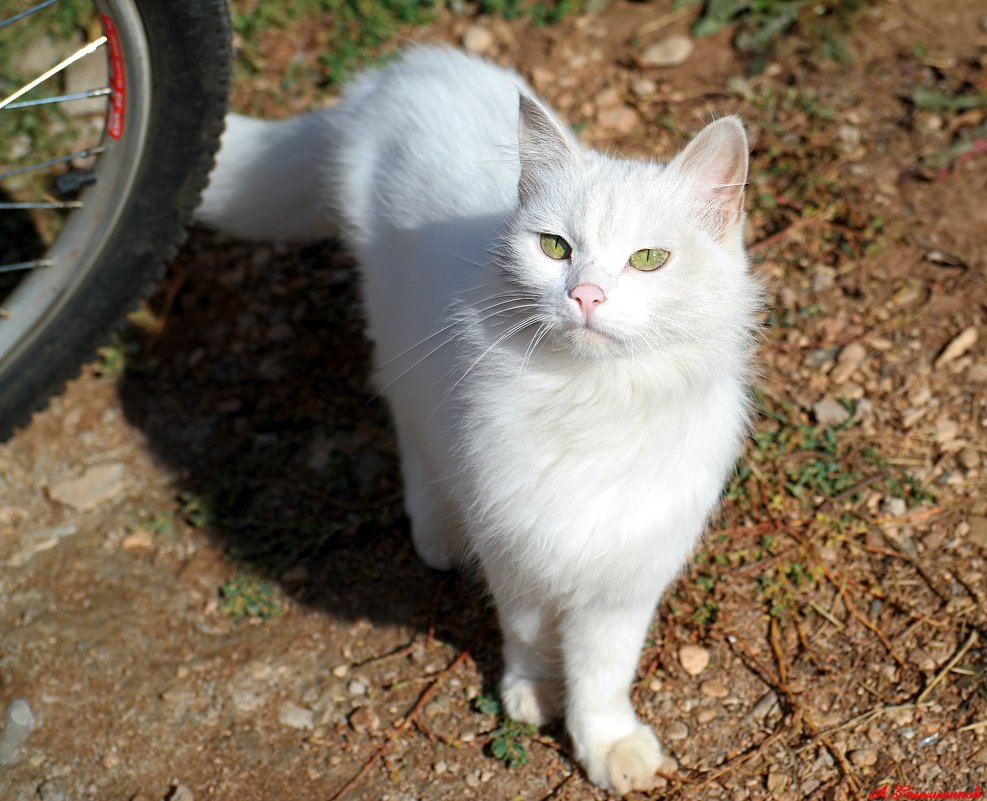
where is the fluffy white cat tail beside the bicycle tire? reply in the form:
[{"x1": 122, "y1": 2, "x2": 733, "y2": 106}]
[{"x1": 196, "y1": 111, "x2": 336, "y2": 242}]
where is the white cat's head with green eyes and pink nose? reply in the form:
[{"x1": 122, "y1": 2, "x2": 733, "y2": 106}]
[{"x1": 498, "y1": 96, "x2": 757, "y2": 366}]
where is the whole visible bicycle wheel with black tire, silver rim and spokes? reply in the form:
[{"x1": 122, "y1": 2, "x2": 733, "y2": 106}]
[{"x1": 0, "y1": 0, "x2": 230, "y2": 439}]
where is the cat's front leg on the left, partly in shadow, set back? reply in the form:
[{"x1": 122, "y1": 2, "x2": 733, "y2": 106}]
[{"x1": 481, "y1": 555, "x2": 564, "y2": 726}]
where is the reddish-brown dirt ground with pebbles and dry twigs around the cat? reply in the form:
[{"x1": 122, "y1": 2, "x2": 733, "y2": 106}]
[{"x1": 0, "y1": 0, "x2": 987, "y2": 801}]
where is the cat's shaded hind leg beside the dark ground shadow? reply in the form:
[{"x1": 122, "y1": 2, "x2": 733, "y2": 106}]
[{"x1": 398, "y1": 426, "x2": 465, "y2": 570}]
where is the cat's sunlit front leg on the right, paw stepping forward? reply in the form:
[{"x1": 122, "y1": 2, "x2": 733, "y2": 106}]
[{"x1": 561, "y1": 593, "x2": 662, "y2": 795}]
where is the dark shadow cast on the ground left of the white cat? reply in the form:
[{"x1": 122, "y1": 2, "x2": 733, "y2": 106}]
[{"x1": 121, "y1": 231, "x2": 500, "y2": 686}]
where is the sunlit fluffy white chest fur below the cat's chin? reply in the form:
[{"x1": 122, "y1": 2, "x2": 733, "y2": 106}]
[{"x1": 461, "y1": 346, "x2": 746, "y2": 589}]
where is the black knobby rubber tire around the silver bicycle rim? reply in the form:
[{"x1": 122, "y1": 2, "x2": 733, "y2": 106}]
[{"x1": 0, "y1": 0, "x2": 231, "y2": 441}]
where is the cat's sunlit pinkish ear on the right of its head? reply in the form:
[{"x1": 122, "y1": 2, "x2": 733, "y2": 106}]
[{"x1": 668, "y1": 116, "x2": 748, "y2": 239}]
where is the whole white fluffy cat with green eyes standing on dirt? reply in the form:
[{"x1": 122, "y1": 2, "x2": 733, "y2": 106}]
[{"x1": 200, "y1": 48, "x2": 759, "y2": 793}]
